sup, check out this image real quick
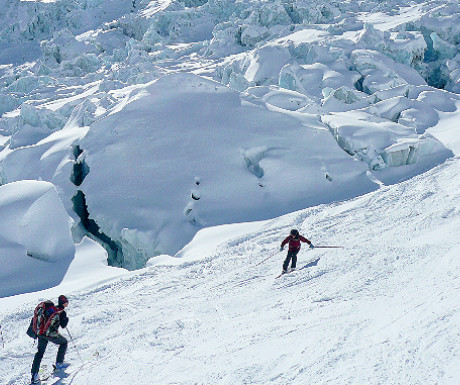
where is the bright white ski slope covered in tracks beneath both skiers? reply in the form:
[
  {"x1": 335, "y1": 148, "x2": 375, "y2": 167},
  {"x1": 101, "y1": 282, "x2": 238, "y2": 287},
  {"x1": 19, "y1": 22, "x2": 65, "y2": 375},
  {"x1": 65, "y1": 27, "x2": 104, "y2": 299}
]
[{"x1": 0, "y1": 159, "x2": 460, "y2": 385}]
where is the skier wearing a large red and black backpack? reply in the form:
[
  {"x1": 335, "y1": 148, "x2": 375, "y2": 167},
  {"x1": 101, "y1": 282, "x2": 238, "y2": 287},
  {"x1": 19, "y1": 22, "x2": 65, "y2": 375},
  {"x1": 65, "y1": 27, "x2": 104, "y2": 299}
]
[{"x1": 28, "y1": 295, "x2": 70, "y2": 384}]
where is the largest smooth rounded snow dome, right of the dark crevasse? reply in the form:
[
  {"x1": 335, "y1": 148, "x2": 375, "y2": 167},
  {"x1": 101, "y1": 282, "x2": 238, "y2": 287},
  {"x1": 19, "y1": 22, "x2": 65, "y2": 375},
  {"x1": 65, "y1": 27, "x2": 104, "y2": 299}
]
[{"x1": 80, "y1": 74, "x2": 376, "y2": 268}]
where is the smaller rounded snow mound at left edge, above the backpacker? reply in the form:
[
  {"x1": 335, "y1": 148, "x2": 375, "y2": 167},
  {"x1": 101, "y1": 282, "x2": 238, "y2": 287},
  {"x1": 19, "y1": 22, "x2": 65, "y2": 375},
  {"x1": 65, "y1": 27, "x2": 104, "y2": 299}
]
[{"x1": 0, "y1": 181, "x2": 75, "y2": 297}]
